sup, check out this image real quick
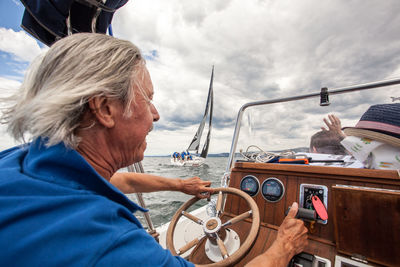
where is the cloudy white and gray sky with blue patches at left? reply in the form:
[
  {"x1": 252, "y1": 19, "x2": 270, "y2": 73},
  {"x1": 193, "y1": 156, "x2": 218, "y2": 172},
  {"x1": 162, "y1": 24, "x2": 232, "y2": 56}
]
[{"x1": 0, "y1": 0, "x2": 400, "y2": 155}]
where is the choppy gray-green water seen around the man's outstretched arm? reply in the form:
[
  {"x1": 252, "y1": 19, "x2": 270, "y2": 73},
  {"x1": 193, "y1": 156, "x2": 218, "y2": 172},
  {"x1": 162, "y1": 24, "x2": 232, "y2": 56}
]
[{"x1": 127, "y1": 157, "x2": 228, "y2": 227}]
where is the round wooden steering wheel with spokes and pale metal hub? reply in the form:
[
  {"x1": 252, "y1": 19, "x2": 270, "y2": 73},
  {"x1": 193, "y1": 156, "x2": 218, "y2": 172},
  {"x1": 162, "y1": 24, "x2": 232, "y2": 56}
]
[{"x1": 167, "y1": 187, "x2": 260, "y2": 267}]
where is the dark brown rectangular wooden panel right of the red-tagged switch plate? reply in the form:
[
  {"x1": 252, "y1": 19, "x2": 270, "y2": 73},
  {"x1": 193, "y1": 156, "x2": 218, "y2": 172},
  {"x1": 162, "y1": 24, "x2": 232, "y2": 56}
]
[{"x1": 333, "y1": 187, "x2": 400, "y2": 266}]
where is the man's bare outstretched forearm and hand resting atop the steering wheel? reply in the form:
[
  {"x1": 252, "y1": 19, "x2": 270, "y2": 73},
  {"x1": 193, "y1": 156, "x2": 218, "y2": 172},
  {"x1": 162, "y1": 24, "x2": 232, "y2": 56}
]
[{"x1": 110, "y1": 172, "x2": 214, "y2": 198}]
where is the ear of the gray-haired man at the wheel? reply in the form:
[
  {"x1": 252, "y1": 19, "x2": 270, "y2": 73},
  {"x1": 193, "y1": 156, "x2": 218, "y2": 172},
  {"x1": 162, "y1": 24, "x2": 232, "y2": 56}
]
[{"x1": 89, "y1": 96, "x2": 117, "y2": 128}]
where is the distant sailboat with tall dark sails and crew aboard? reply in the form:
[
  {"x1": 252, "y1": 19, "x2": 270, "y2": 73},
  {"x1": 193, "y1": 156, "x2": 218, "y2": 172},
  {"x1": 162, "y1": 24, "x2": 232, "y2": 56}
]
[{"x1": 171, "y1": 66, "x2": 214, "y2": 166}]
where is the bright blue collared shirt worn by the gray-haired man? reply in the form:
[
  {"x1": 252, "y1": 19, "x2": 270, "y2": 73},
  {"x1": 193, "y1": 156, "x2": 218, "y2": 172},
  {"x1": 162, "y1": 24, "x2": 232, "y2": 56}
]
[{"x1": 0, "y1": 139, "x2": 193, "y2": 266}]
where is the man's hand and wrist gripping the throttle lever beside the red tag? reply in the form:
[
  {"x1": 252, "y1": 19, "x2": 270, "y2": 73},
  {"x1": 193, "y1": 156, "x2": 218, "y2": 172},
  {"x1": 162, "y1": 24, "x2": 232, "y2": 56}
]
[{"x1": 246, "y1": 203, "x2": 307, "y2": 267}]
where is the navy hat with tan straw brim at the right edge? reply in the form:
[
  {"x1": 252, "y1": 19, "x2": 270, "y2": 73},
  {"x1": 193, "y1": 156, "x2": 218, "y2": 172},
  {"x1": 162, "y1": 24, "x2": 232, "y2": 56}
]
[{"x1": 343, "y1": 103, "x2": 400, "y2": 147}]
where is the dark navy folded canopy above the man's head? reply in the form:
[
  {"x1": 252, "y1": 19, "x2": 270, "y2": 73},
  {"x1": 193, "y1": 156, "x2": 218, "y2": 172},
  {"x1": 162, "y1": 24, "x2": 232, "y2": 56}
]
[{"x1": 21, "y1": 0, "x2": 128, "y2": 46}]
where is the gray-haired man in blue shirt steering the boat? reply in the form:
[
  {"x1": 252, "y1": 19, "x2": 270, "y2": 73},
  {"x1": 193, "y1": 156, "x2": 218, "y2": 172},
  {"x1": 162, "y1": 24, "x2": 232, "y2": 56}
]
[{"x1": 0, "y1": 34, "x2": 307, "y2": 266}]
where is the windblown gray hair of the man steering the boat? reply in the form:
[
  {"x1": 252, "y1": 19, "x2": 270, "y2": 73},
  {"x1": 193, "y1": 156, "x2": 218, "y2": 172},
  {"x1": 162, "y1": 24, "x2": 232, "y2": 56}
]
[{"x1": 1, "y1": 33, "x2": 145, "y2": 148}]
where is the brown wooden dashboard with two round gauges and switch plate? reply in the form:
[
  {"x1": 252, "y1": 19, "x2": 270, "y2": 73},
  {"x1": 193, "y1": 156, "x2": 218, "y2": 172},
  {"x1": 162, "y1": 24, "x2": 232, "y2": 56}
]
[{"x1": 190, "y1": 162, "x2": 400, "y2": 266}]
